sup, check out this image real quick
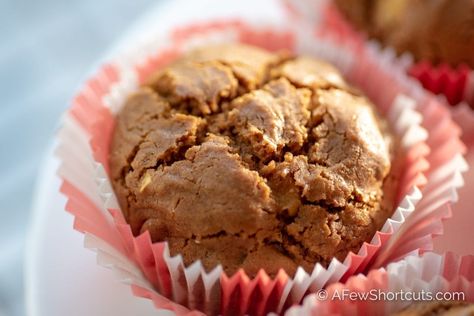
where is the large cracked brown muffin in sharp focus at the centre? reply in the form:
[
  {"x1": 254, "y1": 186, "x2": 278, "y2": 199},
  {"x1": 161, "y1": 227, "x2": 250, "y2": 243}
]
[{"x1": 109, "y1": 45, "x2": 393, "y2": 276}]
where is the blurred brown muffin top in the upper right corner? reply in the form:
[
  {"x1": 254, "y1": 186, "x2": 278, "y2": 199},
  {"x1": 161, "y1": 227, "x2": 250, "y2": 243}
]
[{"x1": 335, "y1": 0, "x2": 474, "y2": 67}]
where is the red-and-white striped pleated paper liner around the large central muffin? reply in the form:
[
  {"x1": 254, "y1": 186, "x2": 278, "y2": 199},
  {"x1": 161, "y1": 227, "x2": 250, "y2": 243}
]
[{"x1": 57, "y1": 21, "x2": 465, "y2": 314}]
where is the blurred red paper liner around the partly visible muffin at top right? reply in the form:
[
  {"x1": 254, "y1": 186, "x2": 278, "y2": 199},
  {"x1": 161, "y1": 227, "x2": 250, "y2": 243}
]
[{"x1": 314, "y1": 0, "x2": 474, "y2": 149}]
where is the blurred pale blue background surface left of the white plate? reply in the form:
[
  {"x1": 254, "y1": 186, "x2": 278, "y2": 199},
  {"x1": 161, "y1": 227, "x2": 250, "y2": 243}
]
[{"x1": 0, "y1": 0, "x2": 159, "y2": 316}]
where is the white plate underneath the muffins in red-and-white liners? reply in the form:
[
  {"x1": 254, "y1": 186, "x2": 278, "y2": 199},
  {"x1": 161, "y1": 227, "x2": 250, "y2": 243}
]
[{"x1": 25, "y1": 0, "x2": 474, "y2": 316}]
